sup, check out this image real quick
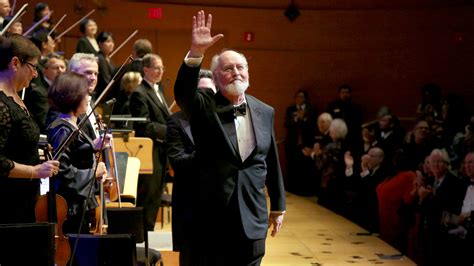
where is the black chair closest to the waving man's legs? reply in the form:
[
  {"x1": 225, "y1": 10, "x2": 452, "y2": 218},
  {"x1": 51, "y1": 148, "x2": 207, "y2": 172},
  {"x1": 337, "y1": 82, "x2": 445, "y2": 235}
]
[{"x1": 107, "y1": 207, "x2": 164, "y2": 266}]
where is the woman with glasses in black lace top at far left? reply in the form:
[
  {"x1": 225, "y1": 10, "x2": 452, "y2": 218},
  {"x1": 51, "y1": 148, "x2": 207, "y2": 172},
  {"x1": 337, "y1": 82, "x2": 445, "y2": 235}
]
[{"x1": 0, "y1": 35, "x2": 59, "y2": 224}]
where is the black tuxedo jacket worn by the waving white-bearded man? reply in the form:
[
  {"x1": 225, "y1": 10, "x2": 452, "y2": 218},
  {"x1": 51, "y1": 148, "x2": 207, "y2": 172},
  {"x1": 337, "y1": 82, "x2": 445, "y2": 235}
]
[{"x1": 174, "y1": 61, "x2": 286, "y2": 239}]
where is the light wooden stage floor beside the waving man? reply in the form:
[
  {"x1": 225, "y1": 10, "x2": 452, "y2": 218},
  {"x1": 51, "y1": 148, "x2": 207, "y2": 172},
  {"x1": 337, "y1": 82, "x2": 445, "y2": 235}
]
[{"x1": 156, "y1": 193, "x2": 415, "y2": 266}]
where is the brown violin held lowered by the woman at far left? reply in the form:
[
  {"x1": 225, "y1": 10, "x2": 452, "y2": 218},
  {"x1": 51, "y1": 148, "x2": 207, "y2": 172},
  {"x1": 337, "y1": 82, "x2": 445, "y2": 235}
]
[{"x1": 35, "y1": 147, "x2": 71, "y2": 266}]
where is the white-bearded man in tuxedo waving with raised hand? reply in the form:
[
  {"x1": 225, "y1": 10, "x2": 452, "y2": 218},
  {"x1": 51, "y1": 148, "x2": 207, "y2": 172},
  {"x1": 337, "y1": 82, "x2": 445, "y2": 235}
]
[{"x1": 175, "y1": 11, "x2": 286, "y2": 265}]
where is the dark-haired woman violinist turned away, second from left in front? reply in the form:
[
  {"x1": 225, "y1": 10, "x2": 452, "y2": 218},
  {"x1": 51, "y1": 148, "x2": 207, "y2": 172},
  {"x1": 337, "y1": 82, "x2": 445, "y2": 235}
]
[{"x1": 48, "y1": 72, "x2": 109, "y2": 233}]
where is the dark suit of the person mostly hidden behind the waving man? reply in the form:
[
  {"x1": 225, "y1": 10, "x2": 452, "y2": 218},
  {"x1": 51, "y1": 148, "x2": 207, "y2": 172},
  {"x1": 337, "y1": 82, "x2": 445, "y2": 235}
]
[{"x1": 166, "y1": 112, "x2": 197, "y2": 251}]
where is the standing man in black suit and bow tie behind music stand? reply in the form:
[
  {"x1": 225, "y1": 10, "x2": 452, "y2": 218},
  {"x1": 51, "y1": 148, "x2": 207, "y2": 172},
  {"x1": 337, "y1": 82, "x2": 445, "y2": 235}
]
[{"x1": 130, "y1": 54, "x2": 169, "y2": 231}]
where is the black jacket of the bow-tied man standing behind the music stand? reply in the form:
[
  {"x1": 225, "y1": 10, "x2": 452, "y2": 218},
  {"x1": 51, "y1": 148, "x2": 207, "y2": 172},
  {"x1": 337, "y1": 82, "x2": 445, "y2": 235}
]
[{"x1": 129, "y1": 80, "x2": 169, "y2": 177}]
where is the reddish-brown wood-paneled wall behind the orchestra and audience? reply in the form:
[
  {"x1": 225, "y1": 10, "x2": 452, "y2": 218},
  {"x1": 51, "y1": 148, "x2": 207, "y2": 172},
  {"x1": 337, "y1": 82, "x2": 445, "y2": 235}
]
[{"x1": 17, "y1": 0, "x2": 474, "y2": 140}]
